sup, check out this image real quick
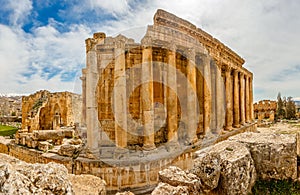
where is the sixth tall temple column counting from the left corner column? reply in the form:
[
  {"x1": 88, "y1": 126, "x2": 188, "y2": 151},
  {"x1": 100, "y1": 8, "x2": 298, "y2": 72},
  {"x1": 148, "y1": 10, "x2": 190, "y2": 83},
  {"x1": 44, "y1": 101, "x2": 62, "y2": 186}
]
[{"x1": 202, "y1": 55, "x2": 211, "y2": 134}]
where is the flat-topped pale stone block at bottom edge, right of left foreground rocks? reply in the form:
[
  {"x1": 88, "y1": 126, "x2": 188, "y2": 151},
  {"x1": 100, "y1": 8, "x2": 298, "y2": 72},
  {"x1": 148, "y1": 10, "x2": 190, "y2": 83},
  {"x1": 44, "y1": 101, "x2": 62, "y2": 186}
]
[{"x1": 69, "y1": 174, "x2": 106, "y2": 195}]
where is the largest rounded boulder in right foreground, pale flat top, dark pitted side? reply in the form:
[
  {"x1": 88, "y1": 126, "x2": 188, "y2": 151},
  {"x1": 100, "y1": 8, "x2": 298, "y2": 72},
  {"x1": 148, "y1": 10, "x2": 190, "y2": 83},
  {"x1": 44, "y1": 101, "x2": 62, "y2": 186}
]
[{"x1": 196, "y1": 141, "x2": 256, "y2": 195}]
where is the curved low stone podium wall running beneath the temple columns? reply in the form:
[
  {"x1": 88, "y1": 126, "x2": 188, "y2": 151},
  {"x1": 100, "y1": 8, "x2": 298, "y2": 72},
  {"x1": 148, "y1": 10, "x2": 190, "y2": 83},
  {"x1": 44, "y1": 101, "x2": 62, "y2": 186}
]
[{"x1": 0, "y1": 139, "x2": 193, "y2": 193}]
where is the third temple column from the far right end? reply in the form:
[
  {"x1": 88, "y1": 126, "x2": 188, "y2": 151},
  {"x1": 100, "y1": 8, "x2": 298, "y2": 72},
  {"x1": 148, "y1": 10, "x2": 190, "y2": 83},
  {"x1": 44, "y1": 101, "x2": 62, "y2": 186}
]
[{"x1": 233, "y1": 70, "x2": 240, "y2": 128}]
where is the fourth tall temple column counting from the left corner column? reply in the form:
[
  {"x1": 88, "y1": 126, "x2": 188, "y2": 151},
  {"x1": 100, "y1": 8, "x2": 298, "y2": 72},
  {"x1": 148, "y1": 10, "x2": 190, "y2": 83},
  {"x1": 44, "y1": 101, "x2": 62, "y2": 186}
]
[{"x1": 166, "y1": 47, "x2": 178, "y2": 142}]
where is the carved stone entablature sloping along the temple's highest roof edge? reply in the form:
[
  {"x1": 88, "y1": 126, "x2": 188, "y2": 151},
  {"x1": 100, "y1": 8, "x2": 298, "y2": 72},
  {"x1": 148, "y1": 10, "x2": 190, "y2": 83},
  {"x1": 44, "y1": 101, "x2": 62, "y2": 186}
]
[{"x1": 154, "y1": 10, "x2": 245, "y2": 66}]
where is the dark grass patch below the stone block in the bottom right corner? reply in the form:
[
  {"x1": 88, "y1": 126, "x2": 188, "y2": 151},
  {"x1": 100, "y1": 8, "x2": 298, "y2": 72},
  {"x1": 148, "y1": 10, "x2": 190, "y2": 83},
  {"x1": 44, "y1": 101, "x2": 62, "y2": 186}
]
[{"x1": 252, "y1": 180, "x2": 300, "y2": 195}]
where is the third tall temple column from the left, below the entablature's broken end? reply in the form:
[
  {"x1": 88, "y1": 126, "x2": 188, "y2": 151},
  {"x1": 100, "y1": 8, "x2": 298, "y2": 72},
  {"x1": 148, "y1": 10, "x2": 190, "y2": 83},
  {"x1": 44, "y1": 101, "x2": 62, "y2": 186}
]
[{"x1": 141, "y1": 37, "x2": 155, "y2": 150}]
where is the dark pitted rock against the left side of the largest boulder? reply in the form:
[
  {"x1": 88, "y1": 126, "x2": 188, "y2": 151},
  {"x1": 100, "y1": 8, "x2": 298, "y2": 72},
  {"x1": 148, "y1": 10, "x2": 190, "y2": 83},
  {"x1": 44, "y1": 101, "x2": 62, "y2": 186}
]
[{"x1": 189, "y1": 153, "x2": 221, "y2": 192}]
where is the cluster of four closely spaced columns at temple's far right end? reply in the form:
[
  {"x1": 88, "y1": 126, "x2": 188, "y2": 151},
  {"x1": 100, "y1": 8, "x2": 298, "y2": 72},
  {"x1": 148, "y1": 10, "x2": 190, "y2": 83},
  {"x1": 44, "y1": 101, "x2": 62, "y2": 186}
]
[{"x1": 224, "y1": 67, "x2": 253, "y2": 130}]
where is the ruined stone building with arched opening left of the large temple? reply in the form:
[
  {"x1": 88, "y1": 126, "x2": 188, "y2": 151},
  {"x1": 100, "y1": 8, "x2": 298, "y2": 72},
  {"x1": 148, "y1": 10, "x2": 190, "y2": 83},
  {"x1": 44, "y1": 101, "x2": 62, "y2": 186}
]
[{"x1": 22, "y1": 90, "x2": 82, "y2": 132}]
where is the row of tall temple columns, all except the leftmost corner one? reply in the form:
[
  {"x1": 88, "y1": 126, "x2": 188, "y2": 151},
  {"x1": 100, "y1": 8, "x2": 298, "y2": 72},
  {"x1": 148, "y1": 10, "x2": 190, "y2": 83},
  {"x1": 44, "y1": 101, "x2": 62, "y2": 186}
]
[{"x1": 110, "y1": 42, "x2": 253, "y2": 150}]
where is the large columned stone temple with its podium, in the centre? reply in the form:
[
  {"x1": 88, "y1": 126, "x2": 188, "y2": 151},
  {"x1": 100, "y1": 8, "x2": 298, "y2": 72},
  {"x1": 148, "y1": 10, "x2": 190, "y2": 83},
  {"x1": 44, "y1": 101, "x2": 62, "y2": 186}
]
[{"x1": 81, "y1": 10, "x2": 255, "y2": 192}]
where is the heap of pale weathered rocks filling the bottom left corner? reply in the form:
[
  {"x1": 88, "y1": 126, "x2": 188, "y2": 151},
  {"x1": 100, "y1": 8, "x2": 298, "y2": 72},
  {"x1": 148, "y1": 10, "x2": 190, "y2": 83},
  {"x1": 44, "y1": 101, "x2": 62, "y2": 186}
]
[{"x1": 0, "y1": 153, "x2": 106, "y2": 195}]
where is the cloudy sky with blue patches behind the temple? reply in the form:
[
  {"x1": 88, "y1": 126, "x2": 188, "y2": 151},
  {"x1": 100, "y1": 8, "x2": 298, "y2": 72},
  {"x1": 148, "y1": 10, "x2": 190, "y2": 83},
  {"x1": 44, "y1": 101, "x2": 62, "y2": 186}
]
[{"x1": 0, "y1": 0, "x2": 300, "y2": 101}]
